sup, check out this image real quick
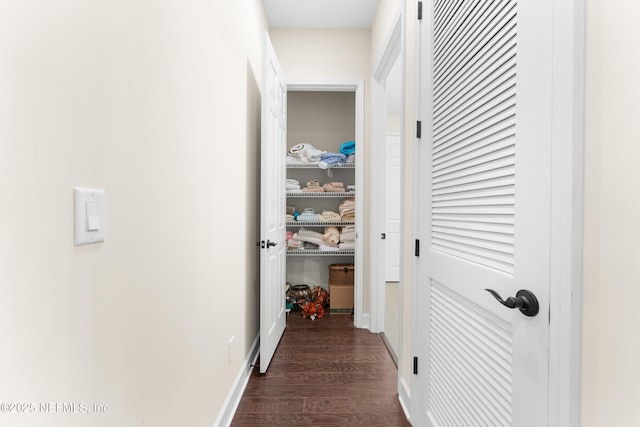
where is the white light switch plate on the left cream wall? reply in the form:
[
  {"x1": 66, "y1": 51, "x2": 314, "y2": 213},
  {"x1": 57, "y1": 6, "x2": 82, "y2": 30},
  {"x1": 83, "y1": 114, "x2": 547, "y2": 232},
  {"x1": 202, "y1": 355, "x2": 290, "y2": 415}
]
[{"x1": 74, "y1": 187, "x2": 106, "y2": 246}]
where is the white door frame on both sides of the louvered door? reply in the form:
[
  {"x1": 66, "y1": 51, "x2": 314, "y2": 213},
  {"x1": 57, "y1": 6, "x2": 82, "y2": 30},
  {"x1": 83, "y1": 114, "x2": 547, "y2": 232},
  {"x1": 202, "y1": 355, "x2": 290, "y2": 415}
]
[{"x1": 411, "y1": 0, "x2": 585, "y2": 427}]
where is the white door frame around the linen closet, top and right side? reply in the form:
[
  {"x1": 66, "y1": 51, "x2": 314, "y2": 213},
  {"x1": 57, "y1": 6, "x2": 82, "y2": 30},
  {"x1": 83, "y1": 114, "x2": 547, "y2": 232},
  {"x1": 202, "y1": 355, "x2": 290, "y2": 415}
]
[{"x1": 285, "y1": 78, "x2": 369, "y2": 328}]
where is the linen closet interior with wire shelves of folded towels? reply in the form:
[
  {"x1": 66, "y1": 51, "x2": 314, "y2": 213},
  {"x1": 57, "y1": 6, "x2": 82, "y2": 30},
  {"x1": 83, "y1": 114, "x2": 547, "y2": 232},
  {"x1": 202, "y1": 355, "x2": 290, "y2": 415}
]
[{"x1": 286, "y1": 91, "x2": 359, "y2": 313}]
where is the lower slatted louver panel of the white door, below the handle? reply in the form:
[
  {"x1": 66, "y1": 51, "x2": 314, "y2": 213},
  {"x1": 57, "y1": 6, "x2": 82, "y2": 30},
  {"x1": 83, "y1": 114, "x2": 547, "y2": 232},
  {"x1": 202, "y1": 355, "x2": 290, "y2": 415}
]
[{"x1": 428, "y1": 281, "x2": 513, "y2": 427}]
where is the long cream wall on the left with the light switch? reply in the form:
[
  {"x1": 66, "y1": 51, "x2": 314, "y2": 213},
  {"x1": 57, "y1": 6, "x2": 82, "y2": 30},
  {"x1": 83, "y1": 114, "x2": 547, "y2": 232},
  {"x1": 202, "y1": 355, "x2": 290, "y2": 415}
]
[{"x1": 0, "y1": 0, "x2": 266, "y2": 427}]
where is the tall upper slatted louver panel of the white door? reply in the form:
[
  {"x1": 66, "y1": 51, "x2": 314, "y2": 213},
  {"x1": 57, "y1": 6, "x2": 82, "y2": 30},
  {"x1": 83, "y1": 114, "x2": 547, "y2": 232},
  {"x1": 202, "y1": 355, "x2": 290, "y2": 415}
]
[{"x1": 431, "y1": 0, "x2": 517, "y2": 276}]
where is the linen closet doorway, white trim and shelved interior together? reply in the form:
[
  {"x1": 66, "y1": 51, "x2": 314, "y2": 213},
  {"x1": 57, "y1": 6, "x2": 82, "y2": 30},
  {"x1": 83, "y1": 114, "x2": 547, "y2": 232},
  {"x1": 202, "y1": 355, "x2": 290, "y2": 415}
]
[{"x1": 286, "y1": 80, "x2": 368, "y2": 327}]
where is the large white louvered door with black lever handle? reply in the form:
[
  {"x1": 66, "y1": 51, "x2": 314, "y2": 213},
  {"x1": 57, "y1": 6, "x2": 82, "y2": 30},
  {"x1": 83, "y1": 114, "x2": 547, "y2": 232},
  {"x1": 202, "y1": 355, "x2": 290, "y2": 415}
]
[{"x1": 420, "y1": 0, "x2": 551, "y2": 427}]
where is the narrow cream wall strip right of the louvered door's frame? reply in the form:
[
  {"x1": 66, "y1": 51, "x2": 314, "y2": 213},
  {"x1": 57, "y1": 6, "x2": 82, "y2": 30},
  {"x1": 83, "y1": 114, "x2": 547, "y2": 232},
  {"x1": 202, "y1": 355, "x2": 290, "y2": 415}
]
[{"x1": 582, "y1": 0, "x2": 640, "y2": 427}]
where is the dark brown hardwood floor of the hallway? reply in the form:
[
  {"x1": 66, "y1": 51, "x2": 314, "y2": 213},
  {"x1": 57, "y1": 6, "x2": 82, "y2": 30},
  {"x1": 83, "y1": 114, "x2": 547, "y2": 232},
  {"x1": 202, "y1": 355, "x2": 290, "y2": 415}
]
[{"x1": 231, "y1": 312, "x2": 411, "y2": 427}]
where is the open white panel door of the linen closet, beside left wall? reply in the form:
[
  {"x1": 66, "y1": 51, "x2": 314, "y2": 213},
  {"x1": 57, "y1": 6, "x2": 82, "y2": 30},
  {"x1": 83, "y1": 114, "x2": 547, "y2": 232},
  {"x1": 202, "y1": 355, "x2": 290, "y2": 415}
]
[{"x1": 260, "y1": 33, "x2": 287, "y2": 373}]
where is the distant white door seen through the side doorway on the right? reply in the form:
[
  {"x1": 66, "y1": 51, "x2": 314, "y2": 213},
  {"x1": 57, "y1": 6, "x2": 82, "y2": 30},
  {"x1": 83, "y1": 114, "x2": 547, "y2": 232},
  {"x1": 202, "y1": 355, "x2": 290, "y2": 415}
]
[{"x1": 384, "y1": 133, "x2": 401, "y2": 282}]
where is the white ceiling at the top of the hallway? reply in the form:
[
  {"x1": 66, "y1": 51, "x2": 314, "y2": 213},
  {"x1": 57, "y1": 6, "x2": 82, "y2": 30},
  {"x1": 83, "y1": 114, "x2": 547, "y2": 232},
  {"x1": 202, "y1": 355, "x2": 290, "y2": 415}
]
[{"x1": 262, "y1": 0, "x2": 378, "y2": 28}]
